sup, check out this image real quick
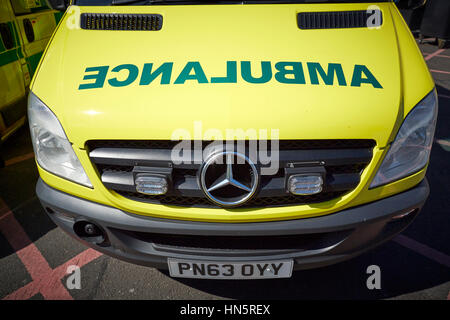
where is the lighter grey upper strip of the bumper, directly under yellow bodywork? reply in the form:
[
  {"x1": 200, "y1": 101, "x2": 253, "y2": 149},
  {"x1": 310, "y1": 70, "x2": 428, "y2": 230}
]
[{"x1": 36, "y1": 179, "x2": 429, "y2": 236}]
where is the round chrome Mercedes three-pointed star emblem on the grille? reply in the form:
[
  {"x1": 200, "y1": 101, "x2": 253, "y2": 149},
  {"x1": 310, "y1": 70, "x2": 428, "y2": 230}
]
[{"x1": 200, "y1": 151, "x2": 259, "y2": 207}]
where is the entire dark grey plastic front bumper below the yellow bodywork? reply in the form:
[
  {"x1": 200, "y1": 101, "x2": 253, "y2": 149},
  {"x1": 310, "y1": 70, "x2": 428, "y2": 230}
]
[{"x1": 36, "y1": 179, "x2": 429, "y2": 269}]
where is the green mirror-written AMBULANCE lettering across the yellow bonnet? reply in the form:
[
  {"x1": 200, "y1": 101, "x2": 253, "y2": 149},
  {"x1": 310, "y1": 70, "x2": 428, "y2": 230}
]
[{"x1": 78, "y1": 61, "x2": 383, "y2": 90}]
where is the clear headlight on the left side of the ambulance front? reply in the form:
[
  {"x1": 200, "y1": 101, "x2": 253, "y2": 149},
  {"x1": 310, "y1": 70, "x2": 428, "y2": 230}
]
[{"x1": 28, "y1": 92, "x2": 92, "y2": 187}]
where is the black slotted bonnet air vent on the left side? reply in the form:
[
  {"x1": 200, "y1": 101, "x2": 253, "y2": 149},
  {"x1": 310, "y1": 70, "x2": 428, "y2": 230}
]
[{"x1": 81, "y1": 13, "x2": 162, "y2": 31}]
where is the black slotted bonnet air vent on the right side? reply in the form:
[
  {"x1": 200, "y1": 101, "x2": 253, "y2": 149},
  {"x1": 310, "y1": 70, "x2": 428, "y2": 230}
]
[{"x1": 297, "y1": 10, "x2": 382, "y2": 29}]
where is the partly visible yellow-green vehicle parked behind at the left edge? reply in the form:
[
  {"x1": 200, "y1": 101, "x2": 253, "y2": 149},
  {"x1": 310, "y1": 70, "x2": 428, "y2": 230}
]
[{"x1": 0, "y1": 0, "x2": 63, "y2": 142}]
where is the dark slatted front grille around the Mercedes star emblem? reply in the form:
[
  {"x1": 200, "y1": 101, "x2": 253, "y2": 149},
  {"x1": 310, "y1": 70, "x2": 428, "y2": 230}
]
[{"x1": 86, "y1": 139, "x2": 375, "y2": 208}]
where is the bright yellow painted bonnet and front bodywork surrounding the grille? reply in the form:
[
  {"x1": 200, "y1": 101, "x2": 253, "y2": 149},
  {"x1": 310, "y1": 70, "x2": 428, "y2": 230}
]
[{"x1": 32, "y1": 3, "x2": 434, "y2": 222}]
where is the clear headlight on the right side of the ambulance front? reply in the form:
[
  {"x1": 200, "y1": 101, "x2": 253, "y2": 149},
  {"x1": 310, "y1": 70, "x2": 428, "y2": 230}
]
[{"x1": 370, "y1": 90, "x2": 438, "y2": 188}]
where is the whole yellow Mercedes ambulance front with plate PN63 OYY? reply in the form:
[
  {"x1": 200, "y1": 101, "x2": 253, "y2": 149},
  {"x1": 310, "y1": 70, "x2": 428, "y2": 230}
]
[{"x1": 28, "y1": 0, "x2": 438, "y2": 279}]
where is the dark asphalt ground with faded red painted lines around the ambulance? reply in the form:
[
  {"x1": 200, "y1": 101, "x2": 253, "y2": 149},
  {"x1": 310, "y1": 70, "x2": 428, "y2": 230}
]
[{"x1": 0, "y1": 44, "x2": 450, "y2": 299}]
